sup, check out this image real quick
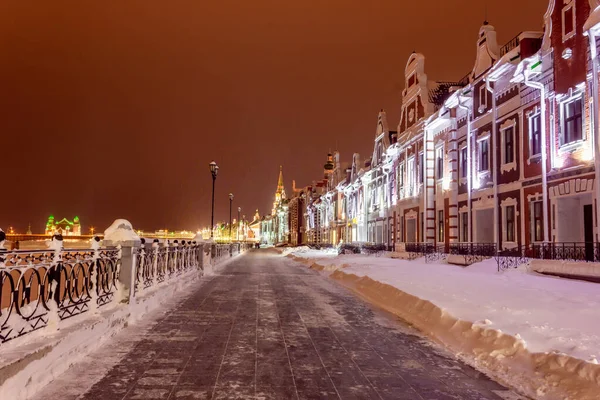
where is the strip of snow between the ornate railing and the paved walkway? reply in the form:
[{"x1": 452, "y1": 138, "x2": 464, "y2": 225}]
[{"x1": 0, "y1": 271, "x2": 200, "y2": 400}]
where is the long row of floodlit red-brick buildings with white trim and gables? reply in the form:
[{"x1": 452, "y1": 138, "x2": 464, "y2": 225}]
[{"x1": 292, "y1": 0, "x2": 600, "y2": 254}]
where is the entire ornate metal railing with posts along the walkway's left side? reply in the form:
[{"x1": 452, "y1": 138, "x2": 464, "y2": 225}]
[{"x1": 0, "y1": 234, "x2": 252, "y2": 345}]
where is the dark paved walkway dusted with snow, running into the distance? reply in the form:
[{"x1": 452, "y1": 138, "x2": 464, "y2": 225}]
[{"x1": 38, "y1": 250, "x2": 518, "y2": 400}]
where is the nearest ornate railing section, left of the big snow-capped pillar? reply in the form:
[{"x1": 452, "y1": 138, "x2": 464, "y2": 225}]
[{"x1": 0, "y1": 246, "x2": 121, "y2": 343}]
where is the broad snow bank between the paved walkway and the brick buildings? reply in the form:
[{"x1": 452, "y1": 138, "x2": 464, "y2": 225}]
[{"x1": 288, "y1": 250, "x2": 600, "y2": 400}]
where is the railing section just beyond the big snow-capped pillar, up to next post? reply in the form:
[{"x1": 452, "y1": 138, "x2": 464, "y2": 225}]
[{"x1": 135, "y1": 239, "x2": 203, "y2": 292}]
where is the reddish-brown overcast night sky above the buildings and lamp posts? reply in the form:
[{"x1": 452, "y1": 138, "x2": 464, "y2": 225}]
[{"x1": 0, "y1": 0, "x2": 548, "y2": 232}]
